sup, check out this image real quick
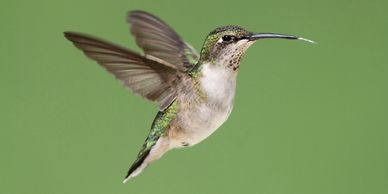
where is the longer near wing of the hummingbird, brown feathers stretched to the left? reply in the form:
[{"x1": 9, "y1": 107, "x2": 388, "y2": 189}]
[{"x1": 65, "y1": 32, "x2": 177, "y2": 110}]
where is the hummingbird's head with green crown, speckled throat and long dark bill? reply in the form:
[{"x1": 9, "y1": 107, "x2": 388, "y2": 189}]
[{"x1": 200, "y1": 25, "x2": 313, "y2": 71}]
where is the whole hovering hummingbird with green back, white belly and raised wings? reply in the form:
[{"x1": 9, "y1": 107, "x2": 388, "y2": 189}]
[{"x1": 64, "y1": 10, "x2": 313, "y2": 183}]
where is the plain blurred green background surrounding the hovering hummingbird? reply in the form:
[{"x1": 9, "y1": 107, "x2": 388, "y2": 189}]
[{"x1": 0, "y1": 0, "x2": 388, "y2": 194}]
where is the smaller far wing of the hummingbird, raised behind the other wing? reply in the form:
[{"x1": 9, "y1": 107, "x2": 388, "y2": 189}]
[{"x1": 127, "y1": 11, "x2": 199, "y2": 71}]
